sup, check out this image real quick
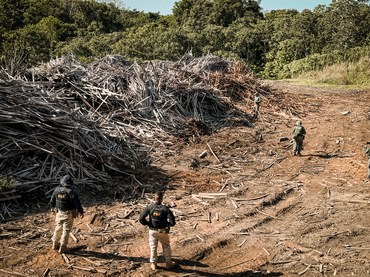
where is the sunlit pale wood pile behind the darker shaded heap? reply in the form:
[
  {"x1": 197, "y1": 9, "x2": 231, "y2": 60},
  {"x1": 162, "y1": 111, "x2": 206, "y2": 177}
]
[{"x1": 29, "y1": 55, "x2": 260, "y2": 139}]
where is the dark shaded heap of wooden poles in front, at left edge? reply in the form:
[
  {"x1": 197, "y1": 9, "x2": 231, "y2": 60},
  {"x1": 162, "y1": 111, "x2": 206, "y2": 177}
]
[{"x1": 0, "y1": 82, "x2": 143, "y2": 189}]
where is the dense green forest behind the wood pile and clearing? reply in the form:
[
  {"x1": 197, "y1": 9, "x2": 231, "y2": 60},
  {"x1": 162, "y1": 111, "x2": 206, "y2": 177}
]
[{"x1": 0, "y1": 0, "x2": 370, "y2": 83}]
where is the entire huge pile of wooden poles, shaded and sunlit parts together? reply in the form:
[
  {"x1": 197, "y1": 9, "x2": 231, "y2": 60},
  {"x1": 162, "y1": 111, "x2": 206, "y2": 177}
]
[{"x1": 0, "y1": 52, "x2": 290, "y2": 216}]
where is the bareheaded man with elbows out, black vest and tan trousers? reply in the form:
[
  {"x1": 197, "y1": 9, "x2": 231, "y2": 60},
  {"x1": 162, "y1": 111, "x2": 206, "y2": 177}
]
[{"x1": 139, "y1": 191, "x2": 176, "y2": 270}]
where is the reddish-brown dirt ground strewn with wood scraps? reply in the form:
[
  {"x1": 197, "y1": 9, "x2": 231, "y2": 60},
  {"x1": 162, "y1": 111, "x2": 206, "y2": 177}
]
[{"x1": 0, "y1": 82, "x2": 370, "y2": 277}]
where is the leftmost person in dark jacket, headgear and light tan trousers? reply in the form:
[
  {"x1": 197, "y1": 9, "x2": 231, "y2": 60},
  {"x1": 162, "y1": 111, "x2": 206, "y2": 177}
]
[{"x1": 50, "y1": 175, "x2": 84, "y2": 253}]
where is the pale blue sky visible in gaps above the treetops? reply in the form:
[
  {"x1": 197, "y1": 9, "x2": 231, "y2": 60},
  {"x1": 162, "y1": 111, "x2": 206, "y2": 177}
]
[{"x1": 120, "y1": 0, "x2": 331, "y2": 15}]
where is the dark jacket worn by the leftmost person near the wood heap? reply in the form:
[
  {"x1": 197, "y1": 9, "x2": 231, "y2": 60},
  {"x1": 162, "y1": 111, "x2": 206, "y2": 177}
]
[{"x1": 50, "y1": 185, "x2": 84, "y2": 214}]
